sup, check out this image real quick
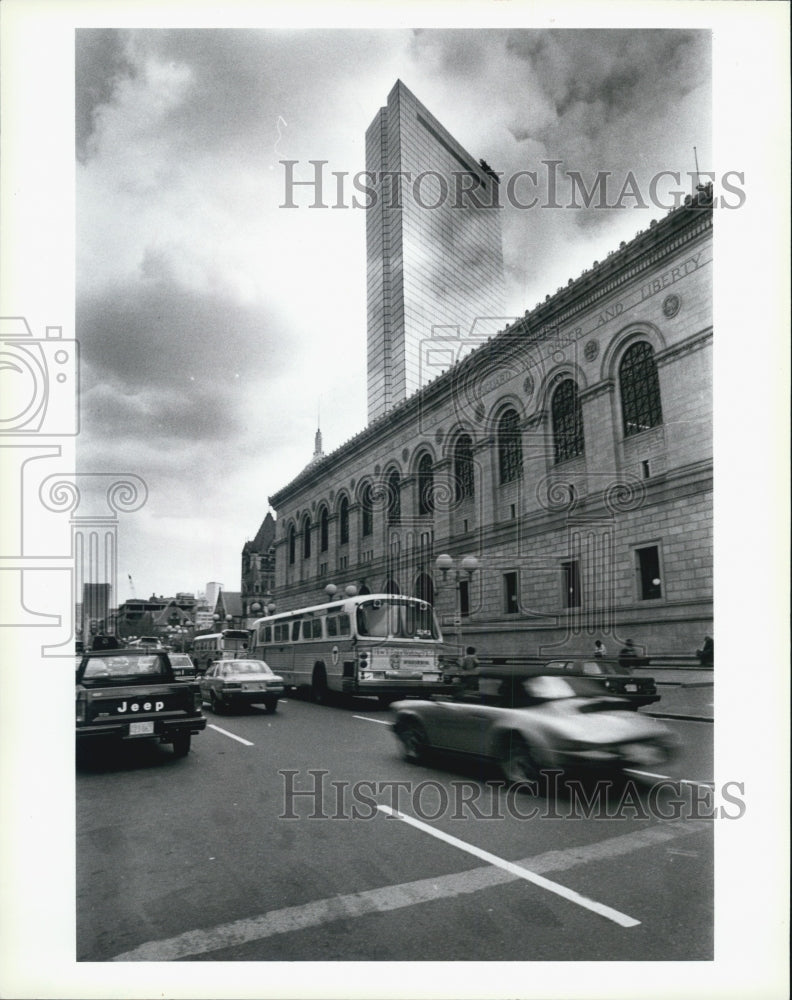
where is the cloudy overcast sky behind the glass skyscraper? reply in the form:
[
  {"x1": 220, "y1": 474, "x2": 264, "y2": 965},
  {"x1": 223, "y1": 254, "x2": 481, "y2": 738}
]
[{"x1": 75, "y1": 29, "x2": 713, "y2": 601}]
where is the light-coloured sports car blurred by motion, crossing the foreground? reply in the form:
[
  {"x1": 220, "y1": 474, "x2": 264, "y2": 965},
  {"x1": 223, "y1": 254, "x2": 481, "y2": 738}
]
[{"x1": 393, "y1": 674, "x2": 676, "y2": 782}]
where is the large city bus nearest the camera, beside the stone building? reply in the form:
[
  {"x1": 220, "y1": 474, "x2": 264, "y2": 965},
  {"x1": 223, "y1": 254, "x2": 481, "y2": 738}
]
[{"x1": 249, "y1": 594, "x2": 452, "y2": 704}]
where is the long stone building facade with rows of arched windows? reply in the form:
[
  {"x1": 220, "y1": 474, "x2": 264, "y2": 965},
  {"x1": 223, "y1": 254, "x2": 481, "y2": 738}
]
[{"x1": 270, "y1": 189, "x2": 713, "y2": 655}]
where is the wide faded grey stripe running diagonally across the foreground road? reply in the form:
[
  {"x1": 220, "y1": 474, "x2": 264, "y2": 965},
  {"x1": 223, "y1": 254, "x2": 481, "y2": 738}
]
[{"x1": 111, "y1": 820, "x2": 712, "y2": 962}]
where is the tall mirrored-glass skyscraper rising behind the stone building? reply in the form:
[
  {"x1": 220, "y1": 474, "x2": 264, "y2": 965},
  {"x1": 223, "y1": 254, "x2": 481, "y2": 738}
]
[{"x1": 366, "y1": 80, "x2": 504, "y2": 421}]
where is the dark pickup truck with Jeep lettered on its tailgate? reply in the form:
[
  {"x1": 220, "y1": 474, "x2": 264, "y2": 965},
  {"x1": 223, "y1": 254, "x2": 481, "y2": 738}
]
[{"x1": 75, "y1": 647, "x2": 206, "y2": 757}]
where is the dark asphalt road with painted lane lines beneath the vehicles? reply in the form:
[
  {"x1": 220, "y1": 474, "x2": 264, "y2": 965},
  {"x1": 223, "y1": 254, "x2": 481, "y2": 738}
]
[{"x1": 77, "y1": 697, "x2": 716, "y2": 962}]
